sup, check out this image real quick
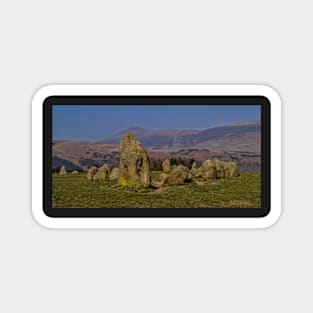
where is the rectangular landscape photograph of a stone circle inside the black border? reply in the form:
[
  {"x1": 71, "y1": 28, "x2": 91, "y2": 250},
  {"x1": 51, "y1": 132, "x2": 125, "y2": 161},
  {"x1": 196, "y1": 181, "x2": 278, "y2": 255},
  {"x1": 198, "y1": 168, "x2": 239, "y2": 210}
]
[{"x1": 51, "y1": 101, "x2": 261, "y2": 209}]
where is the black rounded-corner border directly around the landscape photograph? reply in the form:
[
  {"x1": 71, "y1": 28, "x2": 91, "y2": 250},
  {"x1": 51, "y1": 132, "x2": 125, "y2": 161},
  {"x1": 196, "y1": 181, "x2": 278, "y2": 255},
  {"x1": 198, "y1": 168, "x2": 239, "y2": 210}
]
[{"x1": 42, "y1": 95, "x2": 271, "y2": 218}]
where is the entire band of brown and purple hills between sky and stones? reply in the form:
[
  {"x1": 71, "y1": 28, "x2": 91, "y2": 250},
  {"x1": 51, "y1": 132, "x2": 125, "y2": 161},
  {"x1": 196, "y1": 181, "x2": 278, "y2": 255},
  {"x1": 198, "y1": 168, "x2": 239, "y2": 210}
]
[{"x1": 52, "y1": 121, "x2": 261, "y2": 171}]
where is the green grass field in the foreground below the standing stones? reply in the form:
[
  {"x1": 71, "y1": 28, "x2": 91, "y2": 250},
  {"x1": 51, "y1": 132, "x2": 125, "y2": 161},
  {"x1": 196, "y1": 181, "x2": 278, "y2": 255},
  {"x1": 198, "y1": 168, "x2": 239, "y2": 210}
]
[{"x1": 52, "y1": 172, "x2": 261, "y2": 208}]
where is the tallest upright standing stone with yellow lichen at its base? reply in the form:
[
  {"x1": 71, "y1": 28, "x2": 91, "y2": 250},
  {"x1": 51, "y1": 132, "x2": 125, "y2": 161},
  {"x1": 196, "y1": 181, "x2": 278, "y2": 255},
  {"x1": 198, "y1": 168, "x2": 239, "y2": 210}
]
[{"x1": 118, "y1": 132, "x2": 150, "y2": 187}]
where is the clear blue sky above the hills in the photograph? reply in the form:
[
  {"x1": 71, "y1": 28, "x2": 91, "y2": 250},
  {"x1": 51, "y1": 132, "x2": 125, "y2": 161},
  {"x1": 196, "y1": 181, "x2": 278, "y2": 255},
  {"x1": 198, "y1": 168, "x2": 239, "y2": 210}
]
[{"x1": 52, "y1": 105, "x2": 261, "y2": 141}]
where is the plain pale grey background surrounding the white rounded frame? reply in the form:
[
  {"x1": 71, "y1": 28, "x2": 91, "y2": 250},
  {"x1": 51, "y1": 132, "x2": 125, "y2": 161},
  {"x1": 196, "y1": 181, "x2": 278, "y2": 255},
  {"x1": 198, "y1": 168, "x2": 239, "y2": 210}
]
[{"x1": 0, "y1": 0, "x2": 313, "y2": 313}]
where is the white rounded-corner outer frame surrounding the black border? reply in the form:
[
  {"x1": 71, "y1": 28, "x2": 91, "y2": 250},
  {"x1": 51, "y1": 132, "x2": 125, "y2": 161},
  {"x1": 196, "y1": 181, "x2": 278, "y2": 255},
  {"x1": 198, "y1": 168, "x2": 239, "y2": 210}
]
[{"x1": 32, "y1": 85, "x2": 282, "y2": 229}]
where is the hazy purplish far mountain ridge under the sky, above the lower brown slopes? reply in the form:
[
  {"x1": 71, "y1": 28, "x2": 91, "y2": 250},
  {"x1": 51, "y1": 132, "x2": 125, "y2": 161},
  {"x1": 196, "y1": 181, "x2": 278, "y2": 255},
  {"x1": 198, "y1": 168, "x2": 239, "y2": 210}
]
[{"x1": 103, "y1": 121, "x2": 261, "y2": 153}]
